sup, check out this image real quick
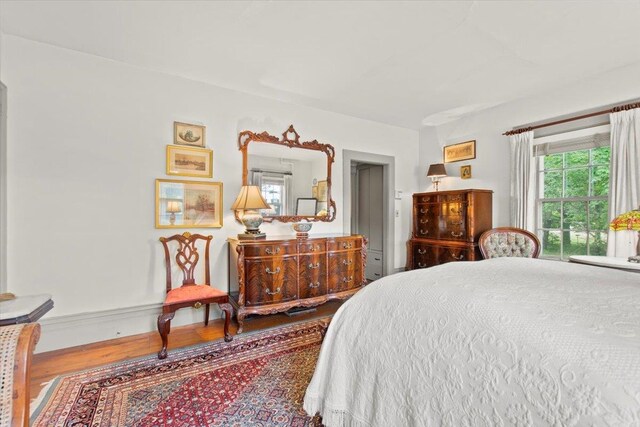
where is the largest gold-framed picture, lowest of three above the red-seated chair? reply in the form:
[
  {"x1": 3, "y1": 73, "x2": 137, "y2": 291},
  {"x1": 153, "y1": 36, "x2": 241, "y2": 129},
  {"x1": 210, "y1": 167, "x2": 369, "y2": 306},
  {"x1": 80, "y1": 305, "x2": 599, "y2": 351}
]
[{"x1": 156, "y1": 179, "x2": 222, "y2": 228}]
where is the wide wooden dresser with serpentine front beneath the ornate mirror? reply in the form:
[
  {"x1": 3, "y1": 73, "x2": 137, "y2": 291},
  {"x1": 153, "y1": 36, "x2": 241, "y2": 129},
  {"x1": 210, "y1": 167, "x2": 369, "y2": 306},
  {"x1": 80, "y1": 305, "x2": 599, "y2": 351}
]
[{"x1": 228, "y1": 234, "x2": 367, "y2": 333}]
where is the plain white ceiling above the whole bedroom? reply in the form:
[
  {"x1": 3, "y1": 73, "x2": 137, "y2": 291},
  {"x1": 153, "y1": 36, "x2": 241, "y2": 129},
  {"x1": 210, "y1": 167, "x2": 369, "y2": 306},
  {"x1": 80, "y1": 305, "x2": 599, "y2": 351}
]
[{"x1": 0, "y1": 0, "x2": 640, "y2": 129}]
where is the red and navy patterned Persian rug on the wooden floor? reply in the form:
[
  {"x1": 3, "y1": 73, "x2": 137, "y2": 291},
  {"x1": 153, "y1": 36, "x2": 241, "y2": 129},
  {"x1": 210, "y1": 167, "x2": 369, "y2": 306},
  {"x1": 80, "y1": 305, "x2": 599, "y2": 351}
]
[{"x1": 32, "y1": 318, "x2": 330, "y2": 427}]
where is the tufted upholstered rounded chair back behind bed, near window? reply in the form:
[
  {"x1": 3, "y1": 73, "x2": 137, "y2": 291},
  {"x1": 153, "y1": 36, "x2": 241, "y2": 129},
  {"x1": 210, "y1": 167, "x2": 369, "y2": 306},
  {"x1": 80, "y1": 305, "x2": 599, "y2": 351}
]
[{"x1": 478, "y1": 227, "x2": 540, "y2": 259}]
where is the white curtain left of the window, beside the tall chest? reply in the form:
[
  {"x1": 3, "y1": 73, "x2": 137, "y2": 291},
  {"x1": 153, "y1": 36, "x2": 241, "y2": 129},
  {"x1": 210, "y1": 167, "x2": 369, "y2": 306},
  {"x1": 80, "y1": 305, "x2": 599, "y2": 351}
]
[{"x1": 510, "y1": 131, "x2": 536, "y2": 232}]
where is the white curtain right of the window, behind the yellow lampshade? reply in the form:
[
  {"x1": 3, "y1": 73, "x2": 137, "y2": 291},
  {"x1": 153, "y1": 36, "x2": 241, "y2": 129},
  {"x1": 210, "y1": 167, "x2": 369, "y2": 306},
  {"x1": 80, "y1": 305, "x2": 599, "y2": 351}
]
[{"x1": 607, "y1": 108, "x2": 640, "y2": 257}]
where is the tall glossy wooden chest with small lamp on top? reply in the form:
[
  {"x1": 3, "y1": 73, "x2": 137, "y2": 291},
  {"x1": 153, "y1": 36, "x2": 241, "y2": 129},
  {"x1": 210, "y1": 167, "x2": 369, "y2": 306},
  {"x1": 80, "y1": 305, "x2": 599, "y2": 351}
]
[{"x1": 406, "y1": 189, "x2": 493, "y2": 270}]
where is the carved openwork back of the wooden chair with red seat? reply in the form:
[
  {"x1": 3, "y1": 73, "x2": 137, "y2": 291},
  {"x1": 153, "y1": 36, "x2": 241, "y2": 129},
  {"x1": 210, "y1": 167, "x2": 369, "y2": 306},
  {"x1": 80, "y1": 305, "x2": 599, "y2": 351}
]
[{"x1": 160, "y1": 232, "x2": 213, "y2": 293}]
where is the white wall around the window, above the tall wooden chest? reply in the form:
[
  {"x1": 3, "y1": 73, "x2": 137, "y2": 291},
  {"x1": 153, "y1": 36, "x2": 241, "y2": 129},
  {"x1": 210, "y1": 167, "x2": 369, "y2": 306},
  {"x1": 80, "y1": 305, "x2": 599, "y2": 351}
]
[{"x1": 420, "y1": 64, "x2": 640, "y2": 227}]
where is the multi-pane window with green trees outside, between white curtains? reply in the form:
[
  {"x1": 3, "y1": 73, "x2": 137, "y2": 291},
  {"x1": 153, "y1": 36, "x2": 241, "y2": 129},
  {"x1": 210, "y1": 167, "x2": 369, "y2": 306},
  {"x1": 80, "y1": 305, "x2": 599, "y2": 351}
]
[{"x1": 534, "y1": 133, "x2": 610, "y2": 259}]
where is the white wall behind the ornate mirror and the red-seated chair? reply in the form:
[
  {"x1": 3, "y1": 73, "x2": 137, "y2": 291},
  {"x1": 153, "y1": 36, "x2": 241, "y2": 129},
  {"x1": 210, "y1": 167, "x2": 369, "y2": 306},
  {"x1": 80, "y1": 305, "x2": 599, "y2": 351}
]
[{"x1": 0, "y1": 34, "x2": 418, "y2": 351}]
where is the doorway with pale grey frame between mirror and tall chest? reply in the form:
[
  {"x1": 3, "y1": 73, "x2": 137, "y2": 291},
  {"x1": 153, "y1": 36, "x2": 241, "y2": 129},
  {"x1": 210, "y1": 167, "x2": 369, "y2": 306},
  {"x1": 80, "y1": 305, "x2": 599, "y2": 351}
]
[{"x1": 343, "y1": 150, "x2": 395, "y2": 280}]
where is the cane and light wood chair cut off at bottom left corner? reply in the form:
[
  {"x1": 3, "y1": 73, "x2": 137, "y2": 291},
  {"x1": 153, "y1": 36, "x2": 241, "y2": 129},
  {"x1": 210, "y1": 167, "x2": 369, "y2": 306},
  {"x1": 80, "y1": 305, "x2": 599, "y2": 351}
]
[{"x1": 0, "y1": 323, "x2": 40, "y2": 427}]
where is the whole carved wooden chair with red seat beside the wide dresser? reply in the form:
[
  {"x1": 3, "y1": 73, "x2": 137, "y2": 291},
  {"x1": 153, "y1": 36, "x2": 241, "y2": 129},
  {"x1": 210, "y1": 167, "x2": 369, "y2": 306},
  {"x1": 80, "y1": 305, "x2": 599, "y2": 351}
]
[{"x1": 158, "y1": 232, "x2": 233, "y2": 359}]
